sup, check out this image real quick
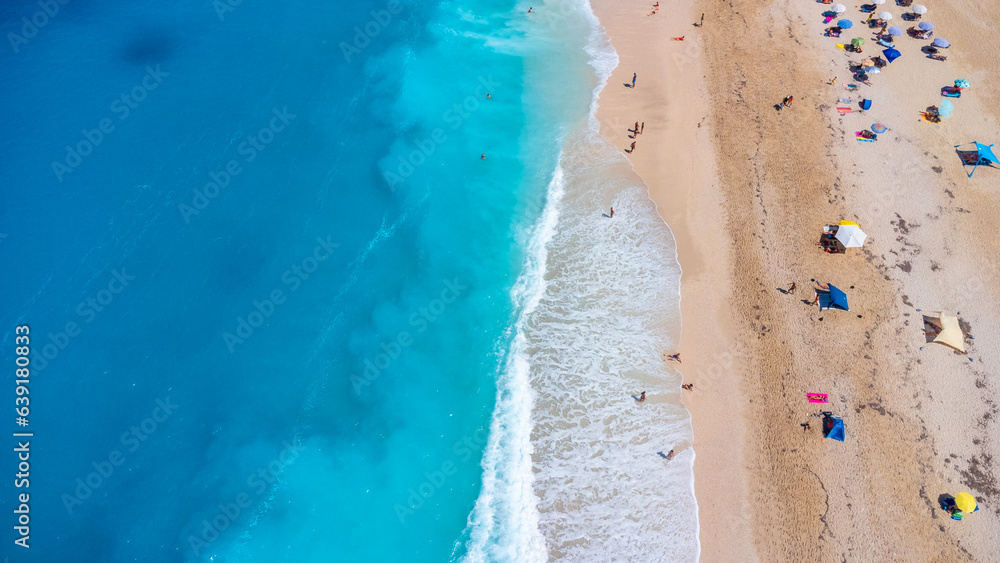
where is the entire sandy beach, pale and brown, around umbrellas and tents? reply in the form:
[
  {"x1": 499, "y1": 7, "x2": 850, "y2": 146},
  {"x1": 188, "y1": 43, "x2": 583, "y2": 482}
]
[{"x1": 594, "y1": 0, "x2": 1000, "y2": 561}]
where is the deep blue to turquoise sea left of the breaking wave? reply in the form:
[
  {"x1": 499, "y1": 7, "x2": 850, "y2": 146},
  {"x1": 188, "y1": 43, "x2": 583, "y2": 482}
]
[{"x1": 0, "y1": 0, "x2": 593, "y2": 562}]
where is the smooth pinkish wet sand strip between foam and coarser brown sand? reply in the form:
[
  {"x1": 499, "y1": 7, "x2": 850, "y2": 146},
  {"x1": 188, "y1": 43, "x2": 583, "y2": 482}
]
[{"x1": 593, "y1": 0, "x2": 755, "y2": 561}]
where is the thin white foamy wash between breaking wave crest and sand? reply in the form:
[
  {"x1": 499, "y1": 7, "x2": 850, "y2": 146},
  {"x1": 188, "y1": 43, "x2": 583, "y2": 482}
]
[{"x1": 524, "y1": 134, "x2": 698, "y2": 561}]
